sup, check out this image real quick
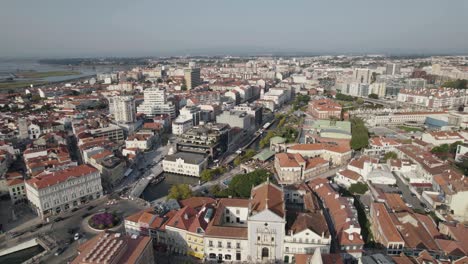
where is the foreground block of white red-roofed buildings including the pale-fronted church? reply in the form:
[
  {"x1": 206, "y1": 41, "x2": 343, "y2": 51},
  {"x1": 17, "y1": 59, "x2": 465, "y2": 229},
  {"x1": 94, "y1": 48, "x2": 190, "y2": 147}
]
[{"x1": 125, "y1": 181, "x2": 331, "y2": 263}]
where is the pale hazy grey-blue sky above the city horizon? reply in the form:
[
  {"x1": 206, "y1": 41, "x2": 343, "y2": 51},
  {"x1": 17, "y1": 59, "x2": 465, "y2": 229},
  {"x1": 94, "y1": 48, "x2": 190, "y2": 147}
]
[{"x1": 0, "y1": 0, "x2": 468, "y2": 57}]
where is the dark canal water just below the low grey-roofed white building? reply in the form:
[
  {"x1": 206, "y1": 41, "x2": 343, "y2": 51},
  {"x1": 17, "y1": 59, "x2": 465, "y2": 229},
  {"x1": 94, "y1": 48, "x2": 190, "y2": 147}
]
[{"x1": 141, "y1": 172, "x2": 198, "y2": 201}]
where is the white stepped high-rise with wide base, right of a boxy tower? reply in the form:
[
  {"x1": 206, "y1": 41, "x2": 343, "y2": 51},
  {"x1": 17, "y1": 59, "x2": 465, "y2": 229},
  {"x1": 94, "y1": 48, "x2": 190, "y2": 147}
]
[{"x1": 137, "y1": 87, "x2": 176, "y2": 118}]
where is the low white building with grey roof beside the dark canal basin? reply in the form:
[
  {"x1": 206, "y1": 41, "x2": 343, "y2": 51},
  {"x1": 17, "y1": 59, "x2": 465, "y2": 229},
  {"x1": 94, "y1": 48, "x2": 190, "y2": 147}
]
[{"x1": 162, "y1": 152, "x2": 207, "y2": 177}]
